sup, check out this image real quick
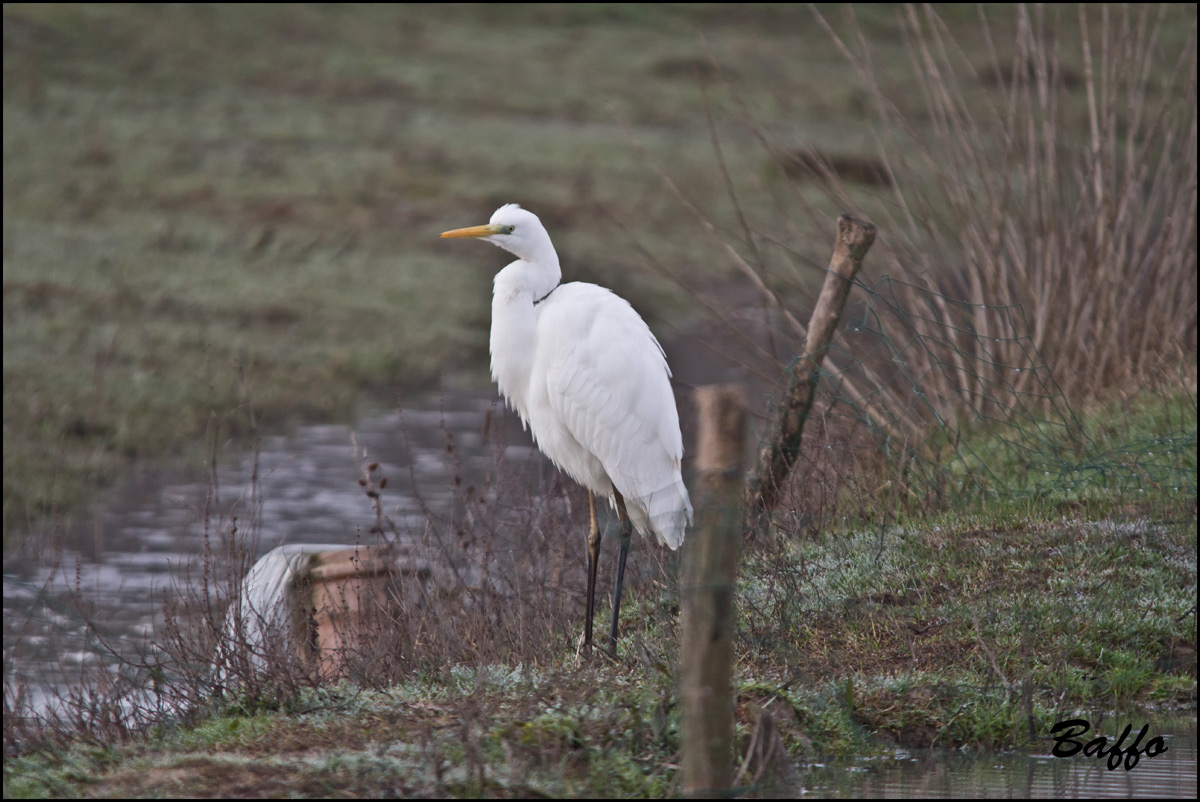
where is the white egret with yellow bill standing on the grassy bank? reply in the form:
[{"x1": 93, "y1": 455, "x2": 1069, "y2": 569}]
[{"x1": 442, "y1": 203, "x2": 691, "y2": 656}]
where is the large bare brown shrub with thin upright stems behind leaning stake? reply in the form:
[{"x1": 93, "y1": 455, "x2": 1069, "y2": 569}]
[{"x1": 638, "y1": 5, "x2": 1196, "y2": 525}]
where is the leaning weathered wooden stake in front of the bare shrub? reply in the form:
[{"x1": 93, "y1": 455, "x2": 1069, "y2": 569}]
[{"x1": 746, "y1": 215, "x2": 875, "y2": 531}]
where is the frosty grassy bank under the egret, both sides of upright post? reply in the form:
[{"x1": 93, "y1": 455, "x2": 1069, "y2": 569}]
[{"x1": 5, "y1": 501, "x2": 1196, "y2": 796}]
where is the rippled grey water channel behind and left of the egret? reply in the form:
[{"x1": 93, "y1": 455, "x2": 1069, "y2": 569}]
[{"x1": 4, "y1": 396, "x2": 542, "y2": 707}]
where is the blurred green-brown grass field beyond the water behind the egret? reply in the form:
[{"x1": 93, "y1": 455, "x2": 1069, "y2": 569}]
[{"x1": 4, "y1": 5, "x2": 883, "y2": 543}]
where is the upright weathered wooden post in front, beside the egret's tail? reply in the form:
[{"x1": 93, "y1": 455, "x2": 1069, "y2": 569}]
[{"x1": 679, "y1": 384, "x2": 746, "y2": 796}]
